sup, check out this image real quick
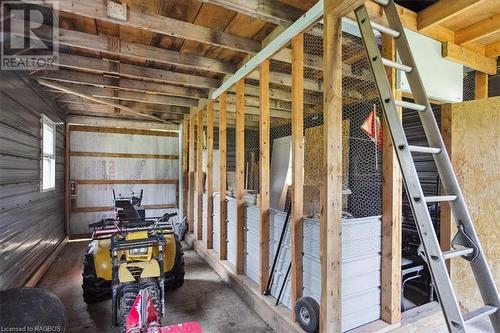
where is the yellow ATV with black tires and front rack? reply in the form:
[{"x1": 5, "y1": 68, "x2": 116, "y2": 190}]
[{"x1": 82, "y1": 191, "x2": 184, "y2": 303}]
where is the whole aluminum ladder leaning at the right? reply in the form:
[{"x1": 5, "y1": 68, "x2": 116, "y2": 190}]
[{"x1": 355, "y1": 0, "x2": 500, "y2": 333}]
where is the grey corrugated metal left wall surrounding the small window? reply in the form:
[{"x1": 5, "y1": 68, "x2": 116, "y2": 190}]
[{"x1": 0, "y1": 71, "x2": 65, "y2": 289}]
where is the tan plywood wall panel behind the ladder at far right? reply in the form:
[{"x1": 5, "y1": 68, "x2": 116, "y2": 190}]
[{"x1": 451, "y1": 97, "x2": 500, "y2": 310}]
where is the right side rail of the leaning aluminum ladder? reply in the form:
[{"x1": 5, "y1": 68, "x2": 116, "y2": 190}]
[{"x1": 384, "y1": 1, "x2": 500, "y2": 326}]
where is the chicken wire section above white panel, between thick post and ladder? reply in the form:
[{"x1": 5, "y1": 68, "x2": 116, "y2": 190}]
[{"x1": 342, "y1": 32, "x2": 383, "y2": 218}]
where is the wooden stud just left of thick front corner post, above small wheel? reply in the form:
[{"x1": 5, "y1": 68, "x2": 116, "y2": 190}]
[{"x1": 290, "y1": 34, "x2": 304, "y2": 314}]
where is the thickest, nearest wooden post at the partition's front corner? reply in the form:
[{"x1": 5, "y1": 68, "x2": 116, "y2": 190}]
[{"x1": 320, "y1": 5, "x2": 342, "y2": 333}]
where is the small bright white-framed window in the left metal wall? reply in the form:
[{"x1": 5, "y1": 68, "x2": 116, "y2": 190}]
[{"x1": 41, "y1": 115, "x2": 56, "y2": 191}]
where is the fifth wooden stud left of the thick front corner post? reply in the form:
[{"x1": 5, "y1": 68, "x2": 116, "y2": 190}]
[{"x1": 207, "y1": 101, "x2": 214, "y2": 249}]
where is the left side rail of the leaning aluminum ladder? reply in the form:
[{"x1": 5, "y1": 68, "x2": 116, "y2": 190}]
[{"x1": 356, "y1": 6, "x2": 465, "y2": 333}]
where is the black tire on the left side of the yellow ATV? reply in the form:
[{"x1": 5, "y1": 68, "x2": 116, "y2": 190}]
[{"x1": 82, "y1": 253, "x2": 111, "y2": 304}]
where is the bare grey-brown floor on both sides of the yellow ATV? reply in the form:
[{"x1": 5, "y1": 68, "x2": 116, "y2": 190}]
[{"x1": 38, "y1": 241, "x2": 272, "y2": 333}]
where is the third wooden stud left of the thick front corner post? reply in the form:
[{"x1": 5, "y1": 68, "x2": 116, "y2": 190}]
[{"x1": 236, "y1": 79, "x2": 245, "y2": 274}]
